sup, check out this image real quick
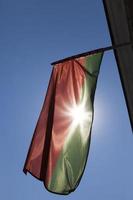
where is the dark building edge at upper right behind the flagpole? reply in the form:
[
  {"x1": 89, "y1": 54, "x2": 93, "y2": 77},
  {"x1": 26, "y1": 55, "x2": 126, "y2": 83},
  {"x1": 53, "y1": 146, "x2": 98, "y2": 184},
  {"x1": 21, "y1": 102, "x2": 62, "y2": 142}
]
[{"x1": 103, "y1": 0, "x2": 133, "y2": 130}]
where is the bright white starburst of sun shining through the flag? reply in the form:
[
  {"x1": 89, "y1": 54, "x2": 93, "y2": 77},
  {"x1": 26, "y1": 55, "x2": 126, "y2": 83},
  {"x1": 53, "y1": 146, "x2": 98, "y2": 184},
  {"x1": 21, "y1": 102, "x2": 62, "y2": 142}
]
[{"x1": 60, "y1": 95, "x2": 93, "y2": 145}]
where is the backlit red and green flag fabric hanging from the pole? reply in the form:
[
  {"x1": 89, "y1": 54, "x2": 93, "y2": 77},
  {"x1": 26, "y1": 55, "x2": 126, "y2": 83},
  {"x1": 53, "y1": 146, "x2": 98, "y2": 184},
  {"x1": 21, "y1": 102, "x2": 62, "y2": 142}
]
[{"x1": 24, "y1": 52, "x2": 103, "y2": 194}]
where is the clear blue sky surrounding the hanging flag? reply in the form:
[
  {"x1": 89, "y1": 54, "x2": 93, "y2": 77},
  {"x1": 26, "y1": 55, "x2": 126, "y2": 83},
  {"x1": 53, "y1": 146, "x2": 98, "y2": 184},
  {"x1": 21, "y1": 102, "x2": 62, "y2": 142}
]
[{"x1": 0, "y1": 0, "x2": 133, "y2": 200}]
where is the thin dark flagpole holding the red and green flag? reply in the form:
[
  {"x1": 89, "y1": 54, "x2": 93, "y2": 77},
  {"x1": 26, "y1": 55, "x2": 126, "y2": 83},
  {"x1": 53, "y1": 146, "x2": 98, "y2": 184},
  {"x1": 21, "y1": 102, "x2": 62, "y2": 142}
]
[{"x1": 51, "y1": 42, "x2": 133, "y2": 65}]
